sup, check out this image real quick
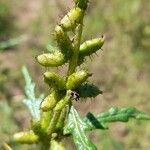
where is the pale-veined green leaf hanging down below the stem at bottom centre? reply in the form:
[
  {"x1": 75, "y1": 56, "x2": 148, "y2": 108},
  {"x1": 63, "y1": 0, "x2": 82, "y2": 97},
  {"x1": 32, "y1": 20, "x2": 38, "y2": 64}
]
[{"x1": 64, "y1": 106, "x2": 97, "y2": 150}]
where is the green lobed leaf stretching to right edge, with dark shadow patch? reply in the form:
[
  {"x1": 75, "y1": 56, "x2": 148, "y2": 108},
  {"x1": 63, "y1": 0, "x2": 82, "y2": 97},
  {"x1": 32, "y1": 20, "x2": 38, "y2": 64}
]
[{"x1": 84, "y1": 107, "x2": 150, "y2": 131}]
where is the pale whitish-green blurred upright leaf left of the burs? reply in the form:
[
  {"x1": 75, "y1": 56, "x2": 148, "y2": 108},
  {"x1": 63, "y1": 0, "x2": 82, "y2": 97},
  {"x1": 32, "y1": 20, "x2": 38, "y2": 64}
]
[{"x1": 22, "y1": 66, "x2": 44, "y2": 120}]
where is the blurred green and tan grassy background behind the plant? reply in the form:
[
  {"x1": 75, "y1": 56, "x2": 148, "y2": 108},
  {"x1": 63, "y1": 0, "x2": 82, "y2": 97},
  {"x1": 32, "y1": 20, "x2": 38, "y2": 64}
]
[{"x1": 0, "y1": 0, "x2": 150, "y2": 150}]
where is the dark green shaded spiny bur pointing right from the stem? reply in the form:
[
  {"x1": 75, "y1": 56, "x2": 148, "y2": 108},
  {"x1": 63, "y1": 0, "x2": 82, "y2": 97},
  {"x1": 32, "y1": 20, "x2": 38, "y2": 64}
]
[{"x1": 75, "y1": 83, "x2": 102, "y2": 98}]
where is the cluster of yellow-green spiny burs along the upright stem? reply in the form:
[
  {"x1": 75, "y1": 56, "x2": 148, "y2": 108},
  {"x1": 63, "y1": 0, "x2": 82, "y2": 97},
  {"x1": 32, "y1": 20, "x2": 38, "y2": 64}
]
[{"x1": 13, "y1": 0, "x2": 104, "y2": 144}]
